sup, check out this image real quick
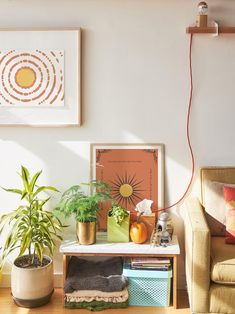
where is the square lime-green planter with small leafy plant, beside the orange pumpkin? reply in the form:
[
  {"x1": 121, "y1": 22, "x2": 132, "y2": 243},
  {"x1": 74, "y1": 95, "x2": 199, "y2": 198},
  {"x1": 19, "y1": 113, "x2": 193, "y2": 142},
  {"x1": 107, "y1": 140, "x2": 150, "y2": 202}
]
[{"x1": 107, "y1": 203, "x2": 130, "y2": 242}]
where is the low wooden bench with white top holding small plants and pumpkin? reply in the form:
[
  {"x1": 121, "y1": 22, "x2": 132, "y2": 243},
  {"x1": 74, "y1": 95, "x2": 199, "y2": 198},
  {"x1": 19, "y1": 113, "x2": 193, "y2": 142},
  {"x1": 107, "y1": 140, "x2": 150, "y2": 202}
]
[{"x1": 60, "y1": 232, "x2": 180, "y2": 308}]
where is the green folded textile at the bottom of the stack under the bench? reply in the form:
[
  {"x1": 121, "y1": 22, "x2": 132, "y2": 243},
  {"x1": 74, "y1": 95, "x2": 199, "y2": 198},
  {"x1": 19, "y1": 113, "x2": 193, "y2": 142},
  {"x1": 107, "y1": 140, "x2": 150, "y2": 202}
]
[{"x1": 65, "y1": 301, "x2": 128, "y2": 311}]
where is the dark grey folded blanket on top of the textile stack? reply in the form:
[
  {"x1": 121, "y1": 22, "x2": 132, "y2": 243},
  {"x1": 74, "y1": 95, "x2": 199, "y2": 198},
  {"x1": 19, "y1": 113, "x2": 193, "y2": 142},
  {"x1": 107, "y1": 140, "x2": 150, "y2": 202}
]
[{"x1": 64, "y1": 256, "x2": 128, "y2": 293}]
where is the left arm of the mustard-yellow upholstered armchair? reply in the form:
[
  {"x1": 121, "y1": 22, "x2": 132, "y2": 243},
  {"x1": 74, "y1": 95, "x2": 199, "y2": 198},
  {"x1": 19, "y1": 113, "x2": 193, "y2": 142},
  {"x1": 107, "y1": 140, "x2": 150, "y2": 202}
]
[{"x1": 184, "y1": 198, "x2": 210, "y2": 313}]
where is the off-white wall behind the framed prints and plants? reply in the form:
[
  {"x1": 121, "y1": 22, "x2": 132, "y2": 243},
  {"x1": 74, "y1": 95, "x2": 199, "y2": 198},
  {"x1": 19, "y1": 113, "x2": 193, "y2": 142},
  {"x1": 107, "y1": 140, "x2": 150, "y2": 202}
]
[{"x1": 0, "y1": 0, "x2": 235, "y2": 287}]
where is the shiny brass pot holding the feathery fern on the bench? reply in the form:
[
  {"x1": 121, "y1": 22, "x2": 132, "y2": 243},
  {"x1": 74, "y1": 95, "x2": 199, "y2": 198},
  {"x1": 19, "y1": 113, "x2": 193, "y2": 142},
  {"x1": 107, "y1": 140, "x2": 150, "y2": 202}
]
[{"x1": 77, "y1": 221, "x2": 96, "y2": 245}]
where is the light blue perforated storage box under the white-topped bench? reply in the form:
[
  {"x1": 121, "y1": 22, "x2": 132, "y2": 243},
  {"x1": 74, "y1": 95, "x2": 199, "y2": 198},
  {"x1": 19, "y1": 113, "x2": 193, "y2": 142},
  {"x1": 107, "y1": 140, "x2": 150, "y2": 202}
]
[{"x1": 123, "y1": 264, "x2": 172, "y2": 306}]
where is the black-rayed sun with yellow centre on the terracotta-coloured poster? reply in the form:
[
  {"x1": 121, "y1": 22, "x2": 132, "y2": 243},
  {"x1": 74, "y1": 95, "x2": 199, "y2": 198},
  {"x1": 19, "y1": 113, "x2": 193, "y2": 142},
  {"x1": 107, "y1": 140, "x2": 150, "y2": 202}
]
[{"x1": 110, "y1": 172, "x2": 145, "y2": 208}]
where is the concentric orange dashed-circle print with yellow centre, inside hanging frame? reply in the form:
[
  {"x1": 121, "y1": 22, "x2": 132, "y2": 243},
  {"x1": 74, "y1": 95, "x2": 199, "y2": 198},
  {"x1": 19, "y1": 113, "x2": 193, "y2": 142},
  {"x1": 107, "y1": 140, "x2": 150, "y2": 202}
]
[{"x1": 0, "y1": 50, "x2": 64, "y2": 107}]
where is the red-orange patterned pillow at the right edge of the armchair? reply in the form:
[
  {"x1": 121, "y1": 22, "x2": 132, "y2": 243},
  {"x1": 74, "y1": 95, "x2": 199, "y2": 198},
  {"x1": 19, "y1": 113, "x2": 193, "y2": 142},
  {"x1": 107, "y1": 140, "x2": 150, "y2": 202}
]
[{"x1": 224, "y1": 186, "x2": 235, "y2": 244}]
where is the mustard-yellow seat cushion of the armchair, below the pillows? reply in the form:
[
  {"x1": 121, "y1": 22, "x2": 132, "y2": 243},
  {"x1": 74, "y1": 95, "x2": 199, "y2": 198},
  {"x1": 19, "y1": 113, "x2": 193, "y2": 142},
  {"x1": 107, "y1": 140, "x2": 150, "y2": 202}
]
[{"x1": 211, "y1": 237, "x2": 235, "y2": 285}]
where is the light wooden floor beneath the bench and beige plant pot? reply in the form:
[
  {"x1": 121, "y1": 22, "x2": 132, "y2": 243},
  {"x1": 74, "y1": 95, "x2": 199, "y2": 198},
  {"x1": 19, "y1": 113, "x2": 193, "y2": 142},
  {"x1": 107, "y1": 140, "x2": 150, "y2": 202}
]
[{"x1": 0, "y1": 288, "x2": 190, "y2": 314}]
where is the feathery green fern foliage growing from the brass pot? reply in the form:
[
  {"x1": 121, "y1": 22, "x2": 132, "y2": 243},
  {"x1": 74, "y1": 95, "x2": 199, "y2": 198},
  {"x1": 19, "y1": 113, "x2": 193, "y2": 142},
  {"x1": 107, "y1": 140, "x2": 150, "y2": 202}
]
[{"x1": 55, "y1": 181, "x2": 112, "y2": 222}]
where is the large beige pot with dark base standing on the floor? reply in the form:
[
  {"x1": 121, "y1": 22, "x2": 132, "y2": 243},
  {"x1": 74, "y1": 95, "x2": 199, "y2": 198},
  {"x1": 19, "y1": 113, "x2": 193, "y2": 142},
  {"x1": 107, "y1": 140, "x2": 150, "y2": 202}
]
[{"x1": 11, "y1": 256, "x2": 54, "y2": 308}]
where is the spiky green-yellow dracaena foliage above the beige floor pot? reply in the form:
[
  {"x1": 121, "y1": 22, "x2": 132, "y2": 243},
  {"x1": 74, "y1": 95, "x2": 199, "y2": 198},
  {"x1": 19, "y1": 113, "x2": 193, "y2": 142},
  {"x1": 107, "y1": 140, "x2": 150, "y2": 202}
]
[{"x1": 0, "y1": 166, "x2": 64, "y2": 267}]
